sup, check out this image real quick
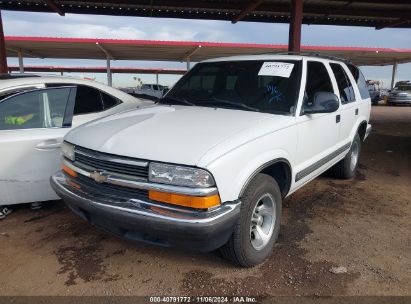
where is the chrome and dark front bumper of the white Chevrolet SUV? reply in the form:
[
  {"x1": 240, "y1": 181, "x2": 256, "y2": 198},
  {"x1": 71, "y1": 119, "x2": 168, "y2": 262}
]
[{"x1": 50, "y1": 172, "x2": 240, "y2": 252}]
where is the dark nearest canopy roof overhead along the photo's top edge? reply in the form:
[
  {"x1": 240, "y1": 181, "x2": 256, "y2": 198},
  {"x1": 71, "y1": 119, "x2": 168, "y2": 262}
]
[{"x1": 0, "y1": 0, "x2": 411, "y2": 28}]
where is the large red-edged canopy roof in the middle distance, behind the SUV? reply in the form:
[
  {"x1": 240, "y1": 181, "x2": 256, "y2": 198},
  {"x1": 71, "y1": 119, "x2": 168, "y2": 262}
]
[{"x1": 6, "y1": 37, "x2": 411, "y2": 65}]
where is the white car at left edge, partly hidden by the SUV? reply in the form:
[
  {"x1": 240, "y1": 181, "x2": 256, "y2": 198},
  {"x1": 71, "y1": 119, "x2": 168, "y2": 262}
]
[{"x1": 0, "y1": 75, "x2": 150, "y2": 206}]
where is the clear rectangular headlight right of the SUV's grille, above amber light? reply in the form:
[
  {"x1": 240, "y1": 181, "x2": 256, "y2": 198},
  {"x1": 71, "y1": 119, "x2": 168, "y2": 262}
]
[{"x1": 149, "y1": 163, "x2": 215, "y2": 187}]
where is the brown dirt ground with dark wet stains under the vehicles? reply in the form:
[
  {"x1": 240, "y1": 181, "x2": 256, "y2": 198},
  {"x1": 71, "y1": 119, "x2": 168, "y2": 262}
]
[{"x1": 0, "y1": 106, "x2": 411, "y2": 296}]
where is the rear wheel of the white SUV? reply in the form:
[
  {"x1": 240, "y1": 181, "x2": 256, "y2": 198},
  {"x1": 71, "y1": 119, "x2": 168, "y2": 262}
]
[{"x1": 332, "y1": 133, "x2": 361, "y2": 179}]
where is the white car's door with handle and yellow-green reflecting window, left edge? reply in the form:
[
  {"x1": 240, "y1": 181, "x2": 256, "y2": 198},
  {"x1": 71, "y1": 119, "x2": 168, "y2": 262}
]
[{"x1": 0, "y1": 87, "x2": 76, "y2": 205}]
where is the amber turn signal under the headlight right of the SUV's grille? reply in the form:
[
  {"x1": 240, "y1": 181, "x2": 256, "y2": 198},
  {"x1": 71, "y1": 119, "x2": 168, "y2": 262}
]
[{"x1": 148, "y1": 190, "x2": 221, "y2": 209}]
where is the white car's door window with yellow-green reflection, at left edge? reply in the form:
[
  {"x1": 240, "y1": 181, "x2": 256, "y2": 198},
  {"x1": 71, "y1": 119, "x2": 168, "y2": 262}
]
[{"x1": 0, "y1": 88, "x2": 71, "y2": 130}]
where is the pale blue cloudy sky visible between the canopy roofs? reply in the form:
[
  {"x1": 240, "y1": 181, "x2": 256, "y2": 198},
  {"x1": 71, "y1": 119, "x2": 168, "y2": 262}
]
[{"x1": 2, "y1": 11, "x2": 411, "y2": 87}]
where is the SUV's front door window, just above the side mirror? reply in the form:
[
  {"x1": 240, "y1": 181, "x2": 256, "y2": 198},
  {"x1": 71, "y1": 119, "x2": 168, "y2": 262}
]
[{"x1": 304, "y1": 61, "x2": 334, "y2": 103}]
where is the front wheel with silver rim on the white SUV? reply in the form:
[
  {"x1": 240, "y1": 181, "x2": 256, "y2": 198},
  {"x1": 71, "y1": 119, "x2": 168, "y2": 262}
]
[{"x1": 220, "y1": 174, "x2": 282, "y2": 267}]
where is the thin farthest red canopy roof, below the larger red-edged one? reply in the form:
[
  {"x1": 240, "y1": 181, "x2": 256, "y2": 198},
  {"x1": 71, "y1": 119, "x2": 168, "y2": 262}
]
[{"x1": 8, "y1": 65, "x2": 187, "y2": 75}]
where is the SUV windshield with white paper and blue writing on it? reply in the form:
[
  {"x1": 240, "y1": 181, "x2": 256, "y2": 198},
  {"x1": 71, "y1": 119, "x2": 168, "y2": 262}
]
[{"x1": 160, "y1": 61, "x2": 301, "y2": 115}]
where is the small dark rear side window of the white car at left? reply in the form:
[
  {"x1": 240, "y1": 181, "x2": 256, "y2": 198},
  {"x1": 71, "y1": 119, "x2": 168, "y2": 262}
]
[{"x1": 74, "y1": 85, "x2": 104, "y2": 115}]
